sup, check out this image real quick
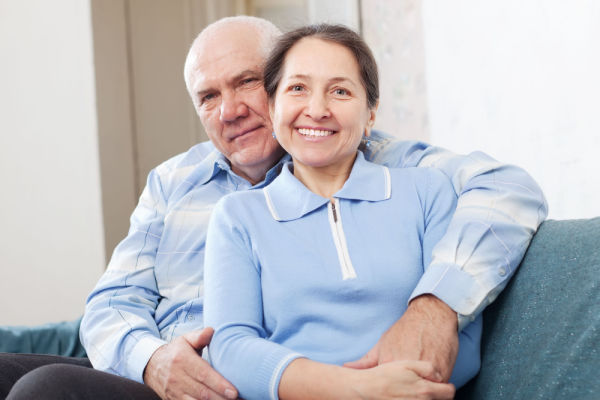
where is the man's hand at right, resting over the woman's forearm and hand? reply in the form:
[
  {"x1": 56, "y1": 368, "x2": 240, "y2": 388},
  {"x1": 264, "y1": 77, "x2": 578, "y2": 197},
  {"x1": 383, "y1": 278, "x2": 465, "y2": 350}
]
[{"x1": 344, "y1": 295, "x2": 458, "y2": 382}]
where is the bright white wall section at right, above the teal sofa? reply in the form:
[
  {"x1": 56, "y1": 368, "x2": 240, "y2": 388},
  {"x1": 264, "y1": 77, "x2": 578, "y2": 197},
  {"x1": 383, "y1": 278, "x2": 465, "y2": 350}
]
[{"x1": 423, "y1": 0, "x2": 600, "y2": 219}]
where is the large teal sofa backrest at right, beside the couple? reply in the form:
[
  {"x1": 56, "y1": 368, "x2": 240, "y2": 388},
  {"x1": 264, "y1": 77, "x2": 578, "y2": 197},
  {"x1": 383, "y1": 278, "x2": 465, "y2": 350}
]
[{"x1": 456, "y1": 218, "x2": 600, "y2": 400}]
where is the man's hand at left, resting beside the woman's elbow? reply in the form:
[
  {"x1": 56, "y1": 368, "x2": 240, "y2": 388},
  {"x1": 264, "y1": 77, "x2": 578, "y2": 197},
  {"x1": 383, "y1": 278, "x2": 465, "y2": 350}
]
[{"x1": 144, "y1": 328, "x2": 237, "y2": 400}]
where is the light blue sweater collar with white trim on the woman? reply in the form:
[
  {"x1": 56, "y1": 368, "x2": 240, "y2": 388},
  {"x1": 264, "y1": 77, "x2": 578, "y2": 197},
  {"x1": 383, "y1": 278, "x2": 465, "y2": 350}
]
[{"x1": 263, "y1": 151, "x2": 392, "y2": 221}]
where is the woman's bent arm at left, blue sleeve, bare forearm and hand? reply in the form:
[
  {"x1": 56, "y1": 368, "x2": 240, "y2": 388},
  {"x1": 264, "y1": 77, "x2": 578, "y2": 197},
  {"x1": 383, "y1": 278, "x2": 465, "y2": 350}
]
[{"x1": 205, "y1": 197, "x2": 454, "y2": 400}]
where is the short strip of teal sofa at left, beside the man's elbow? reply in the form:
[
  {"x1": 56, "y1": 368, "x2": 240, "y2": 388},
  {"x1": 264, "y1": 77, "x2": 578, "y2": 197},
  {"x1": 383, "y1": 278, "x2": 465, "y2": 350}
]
[{"x1": 0, "y1": 318, "x2": 86, "y2": 357}]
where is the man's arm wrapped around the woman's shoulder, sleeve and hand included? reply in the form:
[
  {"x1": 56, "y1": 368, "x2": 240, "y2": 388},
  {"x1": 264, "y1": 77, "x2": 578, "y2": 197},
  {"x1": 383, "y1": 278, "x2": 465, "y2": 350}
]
[{"x1": 356, "y1": 131, "x2": 547, "y2": 380}]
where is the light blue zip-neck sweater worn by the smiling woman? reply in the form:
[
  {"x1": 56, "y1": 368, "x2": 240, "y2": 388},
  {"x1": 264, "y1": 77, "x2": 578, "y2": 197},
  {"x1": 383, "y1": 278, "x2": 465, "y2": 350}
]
[{"x1": 205, "y1": 152, "x2": 481, "y2": 399}]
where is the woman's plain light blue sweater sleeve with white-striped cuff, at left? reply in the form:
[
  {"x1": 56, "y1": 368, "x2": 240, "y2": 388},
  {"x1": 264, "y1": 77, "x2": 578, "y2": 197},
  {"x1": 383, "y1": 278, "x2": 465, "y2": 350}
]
[{"x1": 204, "y1": 198, "x2": 301, "y2": 399}]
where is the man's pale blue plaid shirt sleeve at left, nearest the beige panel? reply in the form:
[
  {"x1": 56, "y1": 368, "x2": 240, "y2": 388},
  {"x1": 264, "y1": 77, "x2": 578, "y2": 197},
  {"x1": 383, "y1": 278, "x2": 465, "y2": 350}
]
[{"x1": 80, "y1": 167, "x2": 166, "y2": 382}]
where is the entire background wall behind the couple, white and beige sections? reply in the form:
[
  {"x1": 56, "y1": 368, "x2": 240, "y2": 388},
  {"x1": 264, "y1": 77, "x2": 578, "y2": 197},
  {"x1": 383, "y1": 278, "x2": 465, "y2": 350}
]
[{"x1": 0, "y1": 0, "x2": 600, "y2": 324}]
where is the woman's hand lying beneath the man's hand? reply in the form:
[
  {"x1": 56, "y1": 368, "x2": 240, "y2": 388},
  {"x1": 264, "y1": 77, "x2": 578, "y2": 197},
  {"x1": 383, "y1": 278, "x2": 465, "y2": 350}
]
[{"x1": 351, "y1": 361, "x2": 455, "y2": 400}]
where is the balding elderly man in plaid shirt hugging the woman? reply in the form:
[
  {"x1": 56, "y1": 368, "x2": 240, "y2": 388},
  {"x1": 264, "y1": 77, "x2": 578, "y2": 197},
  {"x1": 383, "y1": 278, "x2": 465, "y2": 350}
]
[{"x1": 0, "y1": 17, "x2": 546, "y2": 399}]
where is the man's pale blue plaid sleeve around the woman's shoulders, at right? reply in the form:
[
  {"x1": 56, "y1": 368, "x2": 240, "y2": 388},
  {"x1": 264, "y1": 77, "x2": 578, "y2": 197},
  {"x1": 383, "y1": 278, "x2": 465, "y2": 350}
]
[{"x1": 365, "y1": 132, "x2": 548, "y2": 329}]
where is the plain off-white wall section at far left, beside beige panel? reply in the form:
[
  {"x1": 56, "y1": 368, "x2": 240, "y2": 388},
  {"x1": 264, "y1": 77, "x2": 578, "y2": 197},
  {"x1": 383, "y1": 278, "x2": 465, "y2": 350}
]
[{"x1": 0, "y1": 0, "x2": 105, "y2": 324}]
